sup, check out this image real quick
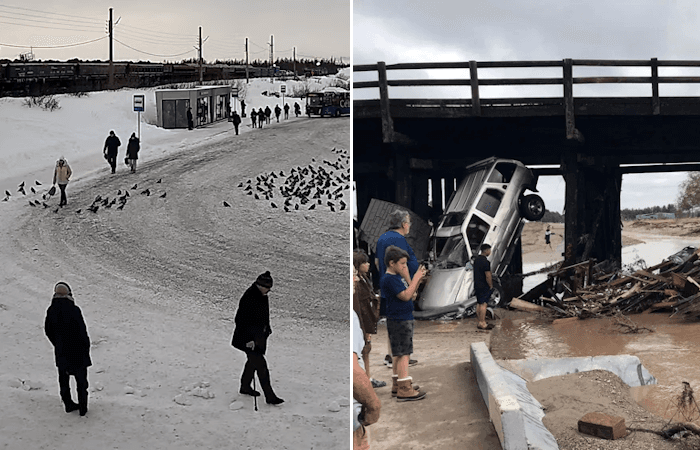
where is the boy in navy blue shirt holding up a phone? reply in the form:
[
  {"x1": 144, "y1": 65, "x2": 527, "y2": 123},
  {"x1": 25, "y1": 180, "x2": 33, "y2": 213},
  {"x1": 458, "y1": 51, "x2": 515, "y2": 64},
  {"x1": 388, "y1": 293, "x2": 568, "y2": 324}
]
[{"x1": 380, "y1": 245, "x2": 426, "y2": 402}]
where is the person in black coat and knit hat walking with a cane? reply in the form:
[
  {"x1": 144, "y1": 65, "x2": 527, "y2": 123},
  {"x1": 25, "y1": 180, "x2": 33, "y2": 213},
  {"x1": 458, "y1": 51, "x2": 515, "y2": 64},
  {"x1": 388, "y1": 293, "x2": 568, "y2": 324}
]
[{"x1": 231, "y1": 271, "x2": 284, "y2": 405}]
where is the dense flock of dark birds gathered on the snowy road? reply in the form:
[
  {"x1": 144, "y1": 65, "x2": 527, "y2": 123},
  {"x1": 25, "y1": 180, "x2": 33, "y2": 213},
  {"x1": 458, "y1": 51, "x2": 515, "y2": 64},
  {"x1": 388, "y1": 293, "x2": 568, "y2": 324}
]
[{"x1": 232, "y1": 148, "x2": 350, "y2": 212}]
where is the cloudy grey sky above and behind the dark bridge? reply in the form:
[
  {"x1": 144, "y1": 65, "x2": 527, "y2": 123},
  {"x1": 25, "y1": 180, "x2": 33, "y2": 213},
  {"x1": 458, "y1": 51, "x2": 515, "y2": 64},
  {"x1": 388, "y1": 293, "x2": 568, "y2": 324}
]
[{"x1": 352, "y1": 0, "x2": 700, "y2": 212}]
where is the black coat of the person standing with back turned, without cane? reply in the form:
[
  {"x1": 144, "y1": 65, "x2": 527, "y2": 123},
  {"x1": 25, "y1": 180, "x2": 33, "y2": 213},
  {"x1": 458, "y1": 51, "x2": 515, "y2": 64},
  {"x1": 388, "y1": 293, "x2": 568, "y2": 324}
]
[{"x1": 44, "y1": 294, "x2": 92, "y2": 371}]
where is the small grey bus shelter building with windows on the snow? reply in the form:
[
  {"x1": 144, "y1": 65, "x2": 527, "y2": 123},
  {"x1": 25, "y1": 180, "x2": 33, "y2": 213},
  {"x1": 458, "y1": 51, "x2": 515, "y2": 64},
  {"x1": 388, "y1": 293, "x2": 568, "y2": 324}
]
[{"x1": 156, "y1": 86, "x2": 231, "y2": 128}]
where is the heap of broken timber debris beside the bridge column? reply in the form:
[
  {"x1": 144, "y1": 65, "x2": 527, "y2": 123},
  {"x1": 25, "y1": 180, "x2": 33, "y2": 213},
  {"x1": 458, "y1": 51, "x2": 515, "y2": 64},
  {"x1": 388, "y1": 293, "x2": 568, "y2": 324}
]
[{"x1": 513, "y1": 247, "x2": 700, "y2": 319}]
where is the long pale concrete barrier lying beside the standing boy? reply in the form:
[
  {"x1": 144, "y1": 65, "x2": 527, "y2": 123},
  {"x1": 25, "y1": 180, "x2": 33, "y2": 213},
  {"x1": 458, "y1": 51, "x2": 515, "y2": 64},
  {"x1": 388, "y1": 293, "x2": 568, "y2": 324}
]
[{"x1": 470, "y1": 342, "x2": 559, "y2": 450}]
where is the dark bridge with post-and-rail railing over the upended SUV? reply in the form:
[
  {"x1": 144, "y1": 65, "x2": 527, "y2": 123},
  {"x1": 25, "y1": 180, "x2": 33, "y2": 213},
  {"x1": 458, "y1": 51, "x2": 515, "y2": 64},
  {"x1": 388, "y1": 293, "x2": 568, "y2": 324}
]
[{"x1": 352, "y1": 58, "x2": 700, "y2": 264}]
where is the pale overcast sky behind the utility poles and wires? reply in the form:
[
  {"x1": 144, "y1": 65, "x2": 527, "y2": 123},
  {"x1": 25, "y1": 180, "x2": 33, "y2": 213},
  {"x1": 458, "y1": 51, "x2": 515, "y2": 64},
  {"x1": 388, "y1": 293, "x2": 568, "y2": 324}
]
[{"x1": 0, "y1": 0, "x2": 350, "y2": 62}]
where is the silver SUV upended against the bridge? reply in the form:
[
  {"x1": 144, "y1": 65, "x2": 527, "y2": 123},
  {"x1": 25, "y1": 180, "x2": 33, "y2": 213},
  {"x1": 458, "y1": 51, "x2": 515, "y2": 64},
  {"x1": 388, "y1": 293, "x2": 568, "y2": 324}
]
[{"x1": 415, "y1": 158, "x2": 545, "y2": 318}]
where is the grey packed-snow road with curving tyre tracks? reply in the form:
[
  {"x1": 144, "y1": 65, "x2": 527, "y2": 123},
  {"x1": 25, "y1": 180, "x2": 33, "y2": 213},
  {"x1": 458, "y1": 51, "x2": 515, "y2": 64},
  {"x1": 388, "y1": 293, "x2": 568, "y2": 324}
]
[{"x1": 0, "y1": 118, "x2": 350, "y2": 449}]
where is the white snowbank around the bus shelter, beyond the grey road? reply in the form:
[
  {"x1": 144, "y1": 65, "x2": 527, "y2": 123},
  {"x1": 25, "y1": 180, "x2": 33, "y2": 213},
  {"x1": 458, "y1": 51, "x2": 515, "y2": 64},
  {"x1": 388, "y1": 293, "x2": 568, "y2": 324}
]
[{"x1": 0, "y1": 68, "x2": 350, "y2": 193}]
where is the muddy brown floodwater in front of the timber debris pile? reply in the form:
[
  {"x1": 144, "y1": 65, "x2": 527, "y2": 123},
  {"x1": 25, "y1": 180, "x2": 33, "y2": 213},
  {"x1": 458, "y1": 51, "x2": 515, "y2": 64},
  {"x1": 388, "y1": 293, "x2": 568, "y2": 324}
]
[{"x1": 491, "y1": 314, "x2": 700, "y2": 424}]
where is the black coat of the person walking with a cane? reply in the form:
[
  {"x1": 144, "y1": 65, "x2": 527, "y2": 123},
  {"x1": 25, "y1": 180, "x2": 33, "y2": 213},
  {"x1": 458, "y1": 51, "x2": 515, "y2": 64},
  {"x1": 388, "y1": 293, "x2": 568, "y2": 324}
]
[{"x1": 231, "y1": 283, "x2": 272, "y2": 355}]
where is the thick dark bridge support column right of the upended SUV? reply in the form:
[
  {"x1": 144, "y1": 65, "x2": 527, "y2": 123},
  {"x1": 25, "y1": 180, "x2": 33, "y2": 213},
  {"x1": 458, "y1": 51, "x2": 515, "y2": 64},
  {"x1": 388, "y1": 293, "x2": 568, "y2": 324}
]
[{"x1": 562, "y1": 151, "x2": 622, "y2": 267}]
